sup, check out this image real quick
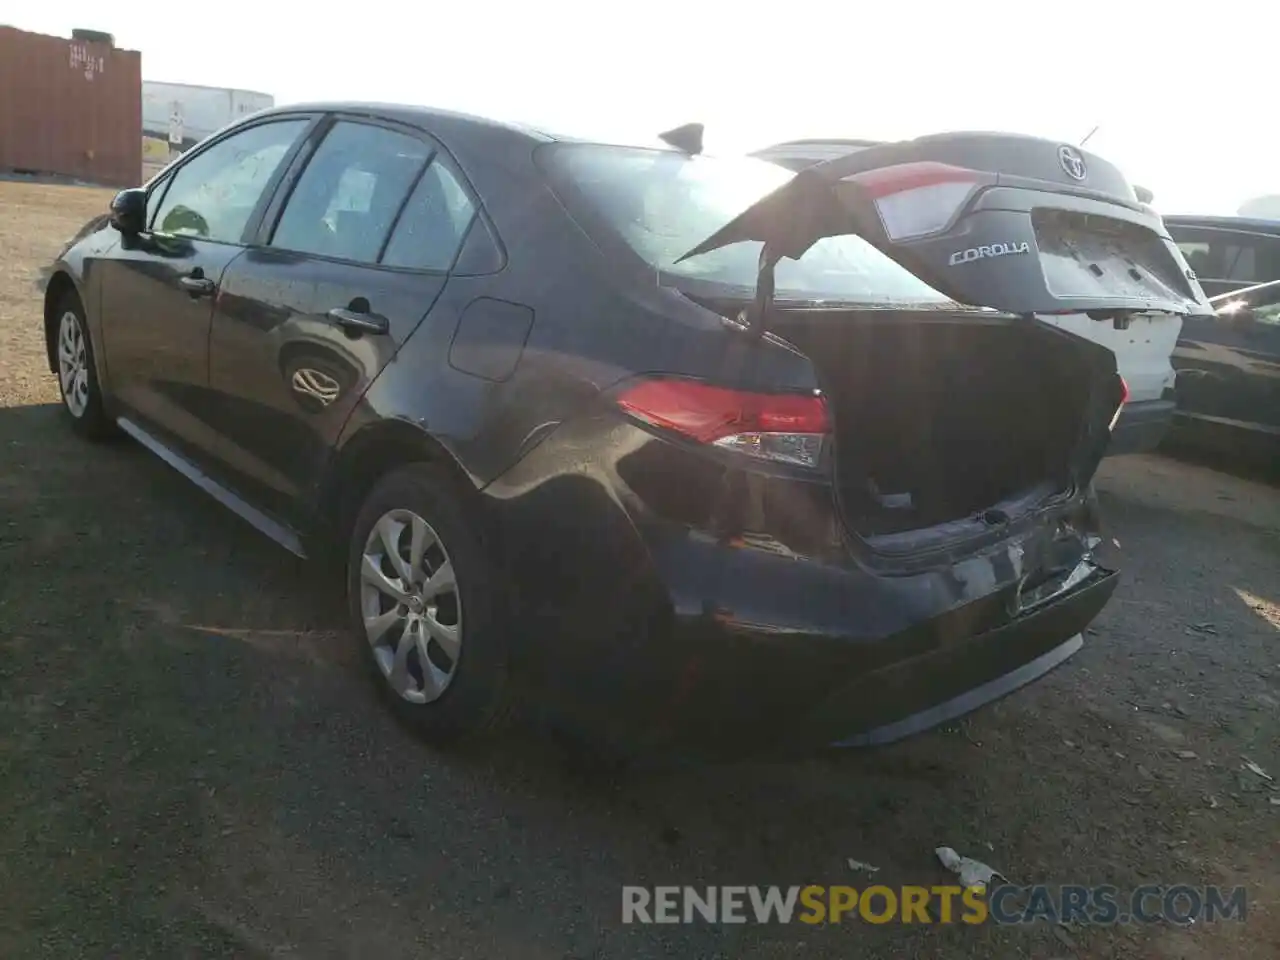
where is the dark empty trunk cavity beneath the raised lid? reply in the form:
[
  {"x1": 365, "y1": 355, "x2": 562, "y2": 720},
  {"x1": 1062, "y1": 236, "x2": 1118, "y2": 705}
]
[{"x1": 769, "y1": 306, "x2": 1124, "y2": 554}]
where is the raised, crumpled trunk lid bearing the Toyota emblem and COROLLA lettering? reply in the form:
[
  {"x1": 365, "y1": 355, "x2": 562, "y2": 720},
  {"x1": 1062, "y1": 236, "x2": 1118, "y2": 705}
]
[{"x1": 681, "y1": 133, "x2": 1213, "y2": 319}]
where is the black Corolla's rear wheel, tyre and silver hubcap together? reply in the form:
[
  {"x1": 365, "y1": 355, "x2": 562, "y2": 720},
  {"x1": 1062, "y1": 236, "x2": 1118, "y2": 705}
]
[{"x1": 347, "y1": 463, "x2": 507, "y2": 744}]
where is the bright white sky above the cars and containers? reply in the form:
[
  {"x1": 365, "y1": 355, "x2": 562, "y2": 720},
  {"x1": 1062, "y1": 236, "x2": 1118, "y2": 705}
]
[{"x1": 12, "y1": 0, "x2": 1280, "y2": 214}]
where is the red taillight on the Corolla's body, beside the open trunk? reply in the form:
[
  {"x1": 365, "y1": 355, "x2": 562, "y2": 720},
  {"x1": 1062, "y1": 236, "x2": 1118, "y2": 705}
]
[{"x1": 617, "y1": 379, "x2": 831, "y2": 467}]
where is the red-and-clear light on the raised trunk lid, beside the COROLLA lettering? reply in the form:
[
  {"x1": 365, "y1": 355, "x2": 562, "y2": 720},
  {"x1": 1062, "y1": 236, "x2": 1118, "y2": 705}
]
[{"x1": 852, "y1": 161, "x2": 992, "y2": 241}]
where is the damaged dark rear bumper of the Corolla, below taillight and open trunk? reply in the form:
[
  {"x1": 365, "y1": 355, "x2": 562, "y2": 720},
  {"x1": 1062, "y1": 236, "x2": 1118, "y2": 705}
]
[{"x1": 490, "y1": 421, "x2": 1114, "y2": 759}]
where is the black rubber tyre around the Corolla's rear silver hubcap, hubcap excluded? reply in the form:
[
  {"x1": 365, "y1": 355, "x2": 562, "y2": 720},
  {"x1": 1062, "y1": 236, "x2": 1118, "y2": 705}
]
[{"x1": 347, "y1": 463, "x2": 509, "y2": 746}]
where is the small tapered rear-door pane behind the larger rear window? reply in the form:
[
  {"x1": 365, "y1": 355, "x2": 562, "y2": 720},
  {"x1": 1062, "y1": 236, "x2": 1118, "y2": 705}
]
[{"x1": 381, "y1": 155, "x2": 476, "y2": 270}]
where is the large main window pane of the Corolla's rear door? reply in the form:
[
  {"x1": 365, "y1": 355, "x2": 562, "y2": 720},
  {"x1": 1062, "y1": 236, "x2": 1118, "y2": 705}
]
[{"x1": 271, "y1": 123, "x2": 431, "y2": 264}]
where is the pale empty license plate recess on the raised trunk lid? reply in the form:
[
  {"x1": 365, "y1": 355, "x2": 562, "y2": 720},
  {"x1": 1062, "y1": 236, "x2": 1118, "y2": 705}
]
[{"x1": 1032, "y1": 209, "x2": 1187, "y2": 306}]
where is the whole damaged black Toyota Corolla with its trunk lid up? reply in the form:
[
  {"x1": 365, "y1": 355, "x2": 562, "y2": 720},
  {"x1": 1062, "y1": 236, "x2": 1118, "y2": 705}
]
[{"x1": 45, "y1": 105, "x2": 1210, "y2": 755}]
